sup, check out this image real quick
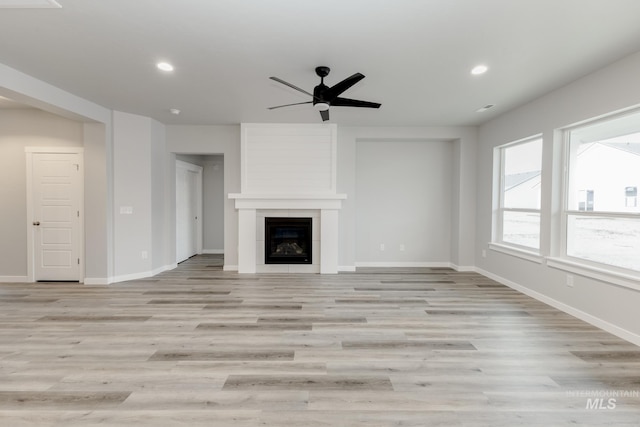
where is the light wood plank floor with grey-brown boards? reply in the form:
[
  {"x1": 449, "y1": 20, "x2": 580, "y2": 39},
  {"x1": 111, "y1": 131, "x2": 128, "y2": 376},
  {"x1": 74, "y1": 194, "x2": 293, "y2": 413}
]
[{"x1": 0, "y1": 256, "x2": 640, "y2": 427}]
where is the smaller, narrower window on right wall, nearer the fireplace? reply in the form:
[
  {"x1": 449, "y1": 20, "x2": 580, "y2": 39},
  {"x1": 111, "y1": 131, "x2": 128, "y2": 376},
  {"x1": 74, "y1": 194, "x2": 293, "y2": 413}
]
[{"x1": 495, "y1": 137, "x2": 542, "y2": 251}]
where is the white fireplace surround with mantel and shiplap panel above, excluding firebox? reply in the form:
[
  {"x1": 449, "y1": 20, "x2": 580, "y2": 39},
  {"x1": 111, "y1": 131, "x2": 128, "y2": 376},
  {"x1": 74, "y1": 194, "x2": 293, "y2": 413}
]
[{"x1": 229, "y1": 123, "x2": 347, "y2": 274}]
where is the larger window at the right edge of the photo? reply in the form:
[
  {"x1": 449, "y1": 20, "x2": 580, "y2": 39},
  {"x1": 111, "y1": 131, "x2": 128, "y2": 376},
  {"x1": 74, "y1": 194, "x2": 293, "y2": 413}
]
[{"x1": 563, "y1": 108, "x2": 640, "y2": 271}]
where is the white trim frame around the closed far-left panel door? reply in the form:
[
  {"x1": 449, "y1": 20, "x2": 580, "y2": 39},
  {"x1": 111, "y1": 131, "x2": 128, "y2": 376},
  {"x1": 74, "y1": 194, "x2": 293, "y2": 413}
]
[{"x1": 24, "y1": 147, "x2": 85, "y2": 283}]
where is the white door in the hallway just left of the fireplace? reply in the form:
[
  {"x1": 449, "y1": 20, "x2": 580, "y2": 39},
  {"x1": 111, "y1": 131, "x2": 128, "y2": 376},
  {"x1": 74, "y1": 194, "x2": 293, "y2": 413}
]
[{"x1": 176, "y1": 161, "x2": 202, "y2": 262}]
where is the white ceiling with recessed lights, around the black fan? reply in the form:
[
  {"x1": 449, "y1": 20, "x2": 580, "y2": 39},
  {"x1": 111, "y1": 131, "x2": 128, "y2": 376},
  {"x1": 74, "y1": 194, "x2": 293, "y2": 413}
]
[{"x1": 0, "y1": 0, "x2": 640, "y2": 126}]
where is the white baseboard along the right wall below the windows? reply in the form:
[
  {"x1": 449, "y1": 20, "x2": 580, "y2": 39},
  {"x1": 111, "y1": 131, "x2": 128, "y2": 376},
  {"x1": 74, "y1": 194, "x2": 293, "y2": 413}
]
[{"x1": 475, "y1": 268, "x2": 640, "y2": 346}]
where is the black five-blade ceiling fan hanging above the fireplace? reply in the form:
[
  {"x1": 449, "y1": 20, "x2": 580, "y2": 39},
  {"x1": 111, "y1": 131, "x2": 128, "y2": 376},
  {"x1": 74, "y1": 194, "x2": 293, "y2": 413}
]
[{"x1": 269, "y1": 66, "x2": 381, "y2": 121}]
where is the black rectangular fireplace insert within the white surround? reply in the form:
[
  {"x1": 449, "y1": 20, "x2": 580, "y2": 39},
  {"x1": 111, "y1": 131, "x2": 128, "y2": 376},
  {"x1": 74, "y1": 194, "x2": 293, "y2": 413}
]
[{"x1": 264, "y1": 217, "x2": 312, "y2": 264}]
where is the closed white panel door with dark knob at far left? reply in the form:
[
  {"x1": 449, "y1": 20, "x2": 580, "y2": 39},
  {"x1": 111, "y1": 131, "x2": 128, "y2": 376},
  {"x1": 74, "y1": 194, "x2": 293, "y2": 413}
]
[{"x1": 30, "y1": 153, "x2": 82, "y2": 281}]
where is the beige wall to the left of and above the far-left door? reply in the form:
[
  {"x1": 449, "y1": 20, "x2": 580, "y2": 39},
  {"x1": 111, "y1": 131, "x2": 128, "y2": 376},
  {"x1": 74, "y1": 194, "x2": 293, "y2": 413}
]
[{"x1": 0, "y1": 109, "x2": 83, "y2": 280}]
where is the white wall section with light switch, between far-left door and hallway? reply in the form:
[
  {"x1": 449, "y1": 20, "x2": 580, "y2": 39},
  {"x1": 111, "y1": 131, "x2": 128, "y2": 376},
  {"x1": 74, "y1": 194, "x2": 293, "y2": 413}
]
[{"x1": 113, "y1": 111, "x2": 169, "y2": 281}]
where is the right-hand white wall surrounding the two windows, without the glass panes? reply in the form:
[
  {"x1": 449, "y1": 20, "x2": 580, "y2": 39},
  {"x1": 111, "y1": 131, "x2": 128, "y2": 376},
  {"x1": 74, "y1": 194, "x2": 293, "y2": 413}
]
[{"x1": 475, "y1": 53, "x2": 640, "y2": 343}]
